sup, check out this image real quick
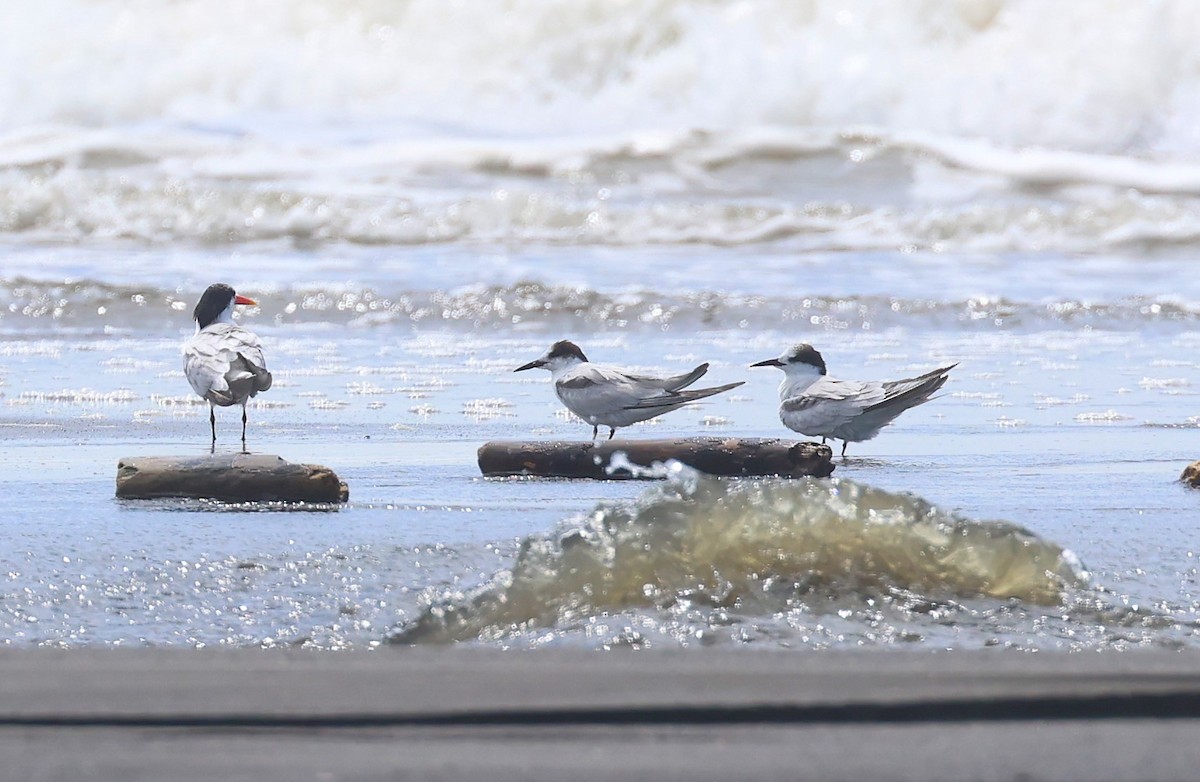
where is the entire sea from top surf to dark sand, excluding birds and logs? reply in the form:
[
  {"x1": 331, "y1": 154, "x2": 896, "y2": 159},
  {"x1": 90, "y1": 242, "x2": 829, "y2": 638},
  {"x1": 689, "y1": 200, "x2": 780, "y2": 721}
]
[{"x1": 0, "y1": 0, "x2": 1200, "y2": 650}]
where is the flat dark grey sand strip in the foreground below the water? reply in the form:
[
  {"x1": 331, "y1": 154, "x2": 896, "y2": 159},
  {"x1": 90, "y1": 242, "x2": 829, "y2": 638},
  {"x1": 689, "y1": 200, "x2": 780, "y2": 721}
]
[{"x1": 0, "y1": 648, "x2": 1200, "y2": 782}]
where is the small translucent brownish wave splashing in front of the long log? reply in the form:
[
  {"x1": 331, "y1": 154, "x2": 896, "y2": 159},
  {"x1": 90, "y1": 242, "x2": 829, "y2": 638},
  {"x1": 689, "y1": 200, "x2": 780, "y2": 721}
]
[{"x1": 392, "y1": 467, "x2": 1086, "y2": 644}]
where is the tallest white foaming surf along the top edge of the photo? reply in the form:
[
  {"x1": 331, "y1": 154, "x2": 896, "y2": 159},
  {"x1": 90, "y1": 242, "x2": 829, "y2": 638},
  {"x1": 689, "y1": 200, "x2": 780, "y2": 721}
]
[{"x1": 0, "y1": 0, "x2": 1200, "y2": 160}]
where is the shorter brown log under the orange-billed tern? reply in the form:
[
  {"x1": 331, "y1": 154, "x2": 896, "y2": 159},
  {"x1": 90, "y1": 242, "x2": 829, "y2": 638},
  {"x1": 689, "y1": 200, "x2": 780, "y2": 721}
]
[{"x1": 116, "y1": 453, "x2": 349, "y2": 503}]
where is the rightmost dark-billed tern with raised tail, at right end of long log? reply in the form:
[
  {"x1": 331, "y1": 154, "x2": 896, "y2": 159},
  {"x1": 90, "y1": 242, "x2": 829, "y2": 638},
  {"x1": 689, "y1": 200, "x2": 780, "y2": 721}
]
[{"x1": 750, "y1": 343, "x2": 958, "y2": 456}]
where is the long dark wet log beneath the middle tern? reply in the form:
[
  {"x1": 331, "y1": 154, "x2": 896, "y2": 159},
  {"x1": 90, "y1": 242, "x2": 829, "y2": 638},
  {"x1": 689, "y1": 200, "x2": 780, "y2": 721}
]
[{"x1": 479, "y1": 438, "x2": 834, "y2": 479}]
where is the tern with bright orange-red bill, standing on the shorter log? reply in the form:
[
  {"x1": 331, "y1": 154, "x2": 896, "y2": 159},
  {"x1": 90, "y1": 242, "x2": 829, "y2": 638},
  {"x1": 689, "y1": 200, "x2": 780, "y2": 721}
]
[{"x1": 184, "y1": 283, "x2": 271, "y2": 450}]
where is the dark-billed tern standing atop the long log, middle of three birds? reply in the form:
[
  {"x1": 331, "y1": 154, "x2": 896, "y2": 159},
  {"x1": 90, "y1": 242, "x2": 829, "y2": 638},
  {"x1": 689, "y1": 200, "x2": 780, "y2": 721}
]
[{"x1": 514, "y1": 339, "x2": 742, "y2": 440}]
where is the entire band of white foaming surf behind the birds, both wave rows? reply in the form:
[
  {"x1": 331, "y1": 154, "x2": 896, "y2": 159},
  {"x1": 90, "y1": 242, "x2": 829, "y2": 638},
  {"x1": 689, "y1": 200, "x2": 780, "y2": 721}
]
[{"x1": 7, "y1": 0, "x2": 1200, "y2": 252}]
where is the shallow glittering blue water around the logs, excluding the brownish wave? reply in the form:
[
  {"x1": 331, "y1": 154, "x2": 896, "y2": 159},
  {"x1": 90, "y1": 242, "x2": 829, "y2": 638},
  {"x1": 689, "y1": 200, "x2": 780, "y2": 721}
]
[{"x1": 0, "y1": 251, "x2": 1200, "y2": 649}]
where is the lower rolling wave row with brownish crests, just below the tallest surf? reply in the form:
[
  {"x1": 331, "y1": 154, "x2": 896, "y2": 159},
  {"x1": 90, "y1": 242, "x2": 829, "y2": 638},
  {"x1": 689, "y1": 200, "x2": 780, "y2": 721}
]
[{"x1": 7, "y1": 128, "x2": 1200, "y2": 252}]
